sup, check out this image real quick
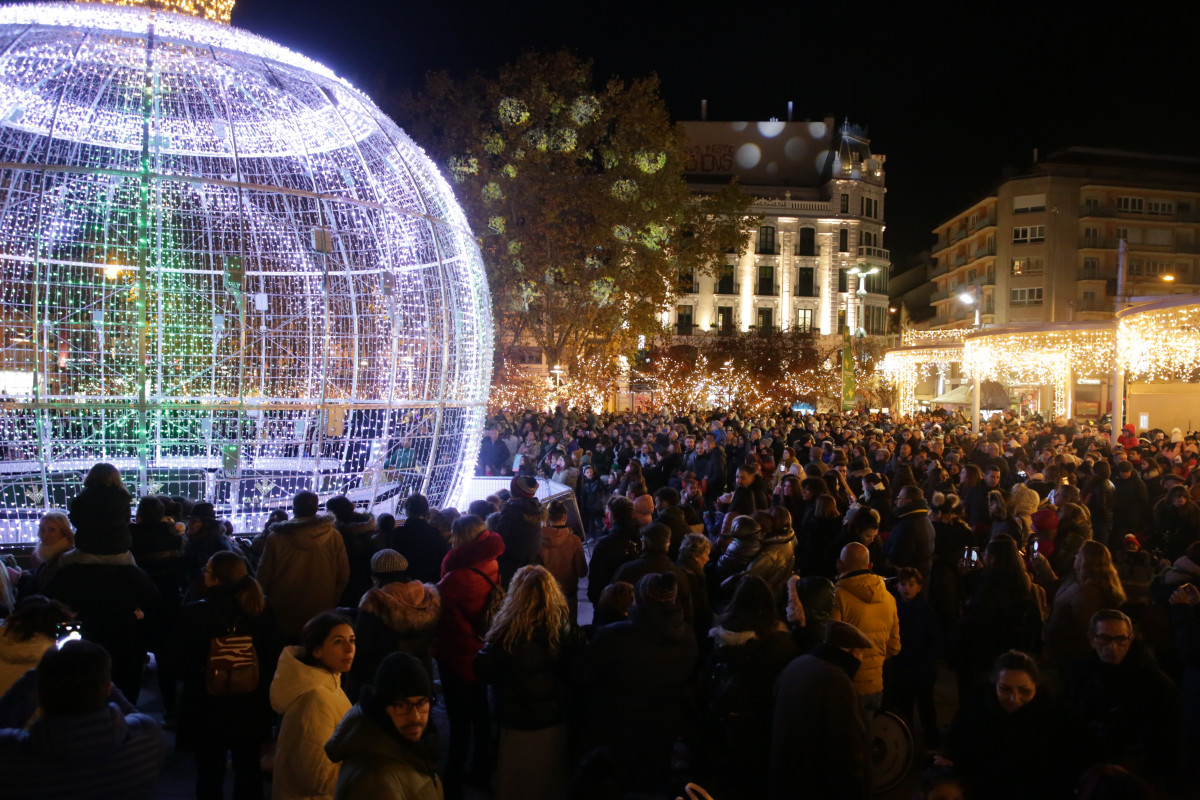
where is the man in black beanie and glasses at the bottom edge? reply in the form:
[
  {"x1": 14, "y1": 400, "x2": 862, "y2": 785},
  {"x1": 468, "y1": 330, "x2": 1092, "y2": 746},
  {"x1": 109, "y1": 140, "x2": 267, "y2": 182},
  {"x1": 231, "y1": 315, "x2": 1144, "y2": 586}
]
[{"x1": 325, "y1": 652, "x2": 444, "y2": 800}]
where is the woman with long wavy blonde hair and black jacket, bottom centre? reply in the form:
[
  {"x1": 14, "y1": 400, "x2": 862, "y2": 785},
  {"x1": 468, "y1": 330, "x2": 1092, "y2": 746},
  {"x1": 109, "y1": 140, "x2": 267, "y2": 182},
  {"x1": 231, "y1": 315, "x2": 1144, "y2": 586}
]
[{"x1": 475, "y1": 565, "x2": 578, "y2": 800}]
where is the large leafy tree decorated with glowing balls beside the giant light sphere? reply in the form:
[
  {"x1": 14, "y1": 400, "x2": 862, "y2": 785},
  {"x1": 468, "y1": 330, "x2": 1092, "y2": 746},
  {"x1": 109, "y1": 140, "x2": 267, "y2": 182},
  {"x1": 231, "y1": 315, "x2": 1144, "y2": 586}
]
[{"x1": 397, "y1": 52, "x2": 750, "y2": 365}]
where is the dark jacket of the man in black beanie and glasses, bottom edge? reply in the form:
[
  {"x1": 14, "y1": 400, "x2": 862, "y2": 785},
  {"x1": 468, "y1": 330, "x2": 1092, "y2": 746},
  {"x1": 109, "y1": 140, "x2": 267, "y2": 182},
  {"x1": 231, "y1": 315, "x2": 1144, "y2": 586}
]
[{"x1": 325, "y1": 686, "x2": 443, "y2": 800}]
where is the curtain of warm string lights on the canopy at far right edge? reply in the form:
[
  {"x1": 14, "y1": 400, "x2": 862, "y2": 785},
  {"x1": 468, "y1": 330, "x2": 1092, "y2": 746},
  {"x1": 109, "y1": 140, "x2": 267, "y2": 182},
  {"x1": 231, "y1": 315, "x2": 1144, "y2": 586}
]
[{"x1": 1117, "y1": 300, "x2": 1200, "y2": 383}]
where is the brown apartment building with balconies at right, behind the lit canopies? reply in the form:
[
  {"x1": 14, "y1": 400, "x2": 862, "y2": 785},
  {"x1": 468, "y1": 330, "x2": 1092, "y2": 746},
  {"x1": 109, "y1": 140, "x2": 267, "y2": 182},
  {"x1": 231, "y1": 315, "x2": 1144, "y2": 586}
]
[{"x1": 926, "y1": 148, "x2": 1200, "y2": 329}]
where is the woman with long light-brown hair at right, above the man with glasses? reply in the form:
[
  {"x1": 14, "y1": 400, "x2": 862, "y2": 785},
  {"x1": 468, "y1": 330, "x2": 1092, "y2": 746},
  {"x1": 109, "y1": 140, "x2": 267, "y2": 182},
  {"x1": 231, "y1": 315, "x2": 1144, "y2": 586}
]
[{"x1": 1033, "y1": 540, "x2": 1126, "y2": 666}]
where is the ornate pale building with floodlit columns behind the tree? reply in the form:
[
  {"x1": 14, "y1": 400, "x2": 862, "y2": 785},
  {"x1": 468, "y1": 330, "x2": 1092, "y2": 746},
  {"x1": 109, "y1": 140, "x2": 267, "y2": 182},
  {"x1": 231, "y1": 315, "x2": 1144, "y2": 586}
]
[{"x1": 662, "y1": 116, "x2": 892, "y2": 336}]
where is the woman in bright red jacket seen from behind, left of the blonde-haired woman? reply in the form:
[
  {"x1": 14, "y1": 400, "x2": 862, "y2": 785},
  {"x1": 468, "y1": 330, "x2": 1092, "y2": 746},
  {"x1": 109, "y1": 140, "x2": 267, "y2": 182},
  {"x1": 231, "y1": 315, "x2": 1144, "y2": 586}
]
[{"x1": 433, "y1": 513, "x2": 504, "y2": 798}]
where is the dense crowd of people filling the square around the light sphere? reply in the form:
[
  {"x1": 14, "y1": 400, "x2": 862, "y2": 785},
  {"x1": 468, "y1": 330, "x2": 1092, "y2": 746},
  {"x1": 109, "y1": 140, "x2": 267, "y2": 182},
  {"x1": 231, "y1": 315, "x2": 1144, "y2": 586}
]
[{"x1": 0, "y1": 408, "x2": 1200, "y2": 800}]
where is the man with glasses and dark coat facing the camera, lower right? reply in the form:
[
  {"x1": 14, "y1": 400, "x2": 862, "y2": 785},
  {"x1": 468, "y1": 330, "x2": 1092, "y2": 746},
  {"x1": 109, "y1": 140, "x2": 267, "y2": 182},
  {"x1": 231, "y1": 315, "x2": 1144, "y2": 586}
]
[{"x1": 1063, "y1": 608, "x2": 1180, "y2": 789}]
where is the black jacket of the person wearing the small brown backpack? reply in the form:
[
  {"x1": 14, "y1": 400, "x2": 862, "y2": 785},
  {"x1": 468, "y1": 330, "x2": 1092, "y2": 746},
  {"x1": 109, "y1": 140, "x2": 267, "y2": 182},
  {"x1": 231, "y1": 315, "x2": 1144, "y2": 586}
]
[{"x1": 168, "y1": 587, "x2": 283, "y2": 750}]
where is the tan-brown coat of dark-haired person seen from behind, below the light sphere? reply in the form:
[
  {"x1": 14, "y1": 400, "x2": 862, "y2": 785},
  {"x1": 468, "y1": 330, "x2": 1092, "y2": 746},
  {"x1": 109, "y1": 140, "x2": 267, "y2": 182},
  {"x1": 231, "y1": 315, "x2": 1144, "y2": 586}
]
[{"x1": 258, "y1": 516, "x2": 350, "y2": 642}]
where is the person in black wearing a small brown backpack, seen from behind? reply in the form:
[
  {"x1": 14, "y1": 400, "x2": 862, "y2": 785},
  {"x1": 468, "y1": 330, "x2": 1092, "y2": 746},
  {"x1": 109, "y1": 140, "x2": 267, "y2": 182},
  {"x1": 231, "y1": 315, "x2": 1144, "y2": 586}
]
[{"x1": 170, "y1": 551, "x2": 283, "y2": 800}]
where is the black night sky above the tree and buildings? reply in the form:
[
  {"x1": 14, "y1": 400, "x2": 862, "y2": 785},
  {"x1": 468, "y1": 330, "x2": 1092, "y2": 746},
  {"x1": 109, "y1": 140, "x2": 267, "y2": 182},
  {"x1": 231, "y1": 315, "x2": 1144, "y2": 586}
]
[{"x1": 233, "y1": 0, "x2": 1200, "y2": 270}]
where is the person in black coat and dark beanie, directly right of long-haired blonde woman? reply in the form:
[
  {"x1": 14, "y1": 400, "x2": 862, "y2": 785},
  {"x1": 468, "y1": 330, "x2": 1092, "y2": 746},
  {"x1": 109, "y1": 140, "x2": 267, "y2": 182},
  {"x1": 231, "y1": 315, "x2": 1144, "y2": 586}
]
[{"x1": 576, "y1": 572, "x2": 697, "y2": 796}]
